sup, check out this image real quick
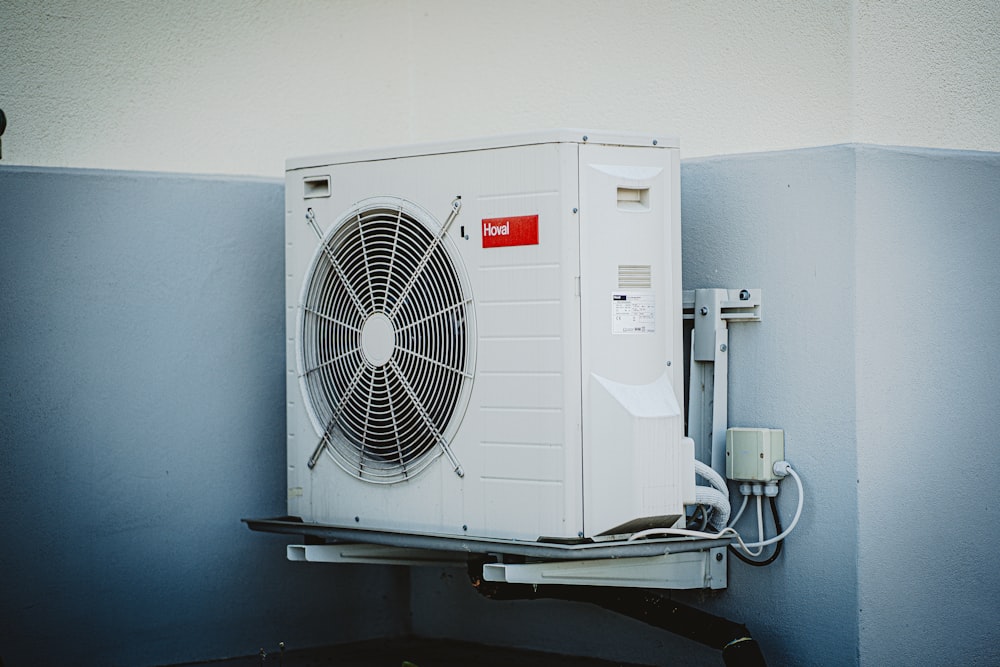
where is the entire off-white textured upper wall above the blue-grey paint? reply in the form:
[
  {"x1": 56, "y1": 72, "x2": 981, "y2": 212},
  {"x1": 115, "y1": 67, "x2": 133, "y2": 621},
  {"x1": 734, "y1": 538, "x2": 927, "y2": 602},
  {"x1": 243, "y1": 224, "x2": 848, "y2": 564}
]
[{"x1": 0, "y1": 0, "x2": 1000, "y2": 176}]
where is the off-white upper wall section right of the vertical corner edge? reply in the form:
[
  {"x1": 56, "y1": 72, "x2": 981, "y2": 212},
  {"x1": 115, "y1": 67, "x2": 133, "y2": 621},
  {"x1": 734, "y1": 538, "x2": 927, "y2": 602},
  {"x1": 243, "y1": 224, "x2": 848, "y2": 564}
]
[{"x1": 852, "y1": 0, "x2": 1000, "y2": 151}]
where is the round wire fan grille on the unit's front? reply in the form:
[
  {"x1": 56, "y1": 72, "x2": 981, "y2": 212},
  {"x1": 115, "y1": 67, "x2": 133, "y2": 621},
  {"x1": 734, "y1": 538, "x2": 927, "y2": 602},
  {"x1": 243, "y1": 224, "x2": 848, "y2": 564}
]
[{"x1": 299, "y1": 199, "x2": 474, "y2": 483}]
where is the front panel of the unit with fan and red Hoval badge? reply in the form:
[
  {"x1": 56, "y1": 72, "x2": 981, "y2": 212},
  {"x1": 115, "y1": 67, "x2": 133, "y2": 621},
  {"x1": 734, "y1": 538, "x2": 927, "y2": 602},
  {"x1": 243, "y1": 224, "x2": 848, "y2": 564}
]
[{"x1": 286, "y1": 144, "x2": 583, "y2": 539}]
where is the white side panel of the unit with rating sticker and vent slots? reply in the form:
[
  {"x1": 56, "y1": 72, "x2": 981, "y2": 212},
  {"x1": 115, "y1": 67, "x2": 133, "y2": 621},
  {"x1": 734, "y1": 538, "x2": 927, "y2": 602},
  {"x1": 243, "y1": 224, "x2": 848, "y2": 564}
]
[{"x1": 579, "y1": 145, "x2": 693, "y2": 534}]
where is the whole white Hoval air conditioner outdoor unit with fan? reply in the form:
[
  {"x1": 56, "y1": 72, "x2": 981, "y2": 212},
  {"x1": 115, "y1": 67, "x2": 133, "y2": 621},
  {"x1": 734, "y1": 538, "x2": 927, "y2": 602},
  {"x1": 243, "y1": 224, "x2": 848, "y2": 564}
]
[{"x1": 286, "y1": 130, "x2": 695, "y2": 541}]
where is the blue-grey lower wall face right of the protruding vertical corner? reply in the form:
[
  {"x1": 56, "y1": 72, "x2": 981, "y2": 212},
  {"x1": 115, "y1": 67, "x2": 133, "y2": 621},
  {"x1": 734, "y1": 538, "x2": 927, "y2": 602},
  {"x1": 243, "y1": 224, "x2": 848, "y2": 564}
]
[{"x1": 856, "y1": 148, "x2": 1000, "y2": 665}]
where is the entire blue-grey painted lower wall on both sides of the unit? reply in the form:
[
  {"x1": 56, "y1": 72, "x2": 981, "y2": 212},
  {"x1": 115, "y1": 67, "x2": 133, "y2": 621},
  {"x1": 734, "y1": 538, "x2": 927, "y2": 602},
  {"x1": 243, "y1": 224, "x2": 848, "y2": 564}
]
[{"x1": 0, "y1": 146, "x2": 1000, "y2": 667}]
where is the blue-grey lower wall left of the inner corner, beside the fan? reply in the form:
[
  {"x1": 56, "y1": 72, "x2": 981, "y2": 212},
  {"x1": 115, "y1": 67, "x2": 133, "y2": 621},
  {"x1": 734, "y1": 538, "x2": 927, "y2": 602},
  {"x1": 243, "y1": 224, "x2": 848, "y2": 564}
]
[{"x1": 0, "y1": 167, "x2": 408, "y2": 667}]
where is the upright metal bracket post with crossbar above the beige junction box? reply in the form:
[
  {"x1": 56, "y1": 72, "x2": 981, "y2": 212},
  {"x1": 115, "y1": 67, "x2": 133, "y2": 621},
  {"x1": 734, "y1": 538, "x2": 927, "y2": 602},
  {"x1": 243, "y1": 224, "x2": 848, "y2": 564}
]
[{"x1": 684, "y1": 289, "x2": 762, "y2": 477}]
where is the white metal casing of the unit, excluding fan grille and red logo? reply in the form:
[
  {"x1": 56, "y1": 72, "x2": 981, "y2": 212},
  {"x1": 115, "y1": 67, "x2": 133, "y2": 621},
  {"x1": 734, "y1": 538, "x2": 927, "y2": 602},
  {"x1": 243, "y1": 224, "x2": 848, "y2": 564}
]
[{"x1": 286, "y1": 130, "x2": 694, "y2": 540}]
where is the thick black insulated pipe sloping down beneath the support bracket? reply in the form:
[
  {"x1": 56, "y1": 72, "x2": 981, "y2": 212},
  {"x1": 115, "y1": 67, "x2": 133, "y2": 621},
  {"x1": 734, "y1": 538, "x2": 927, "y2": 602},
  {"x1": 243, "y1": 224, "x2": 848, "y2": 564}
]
[{"x1": 469, "y1": 562, "x2": 767, "y2": 667}]
